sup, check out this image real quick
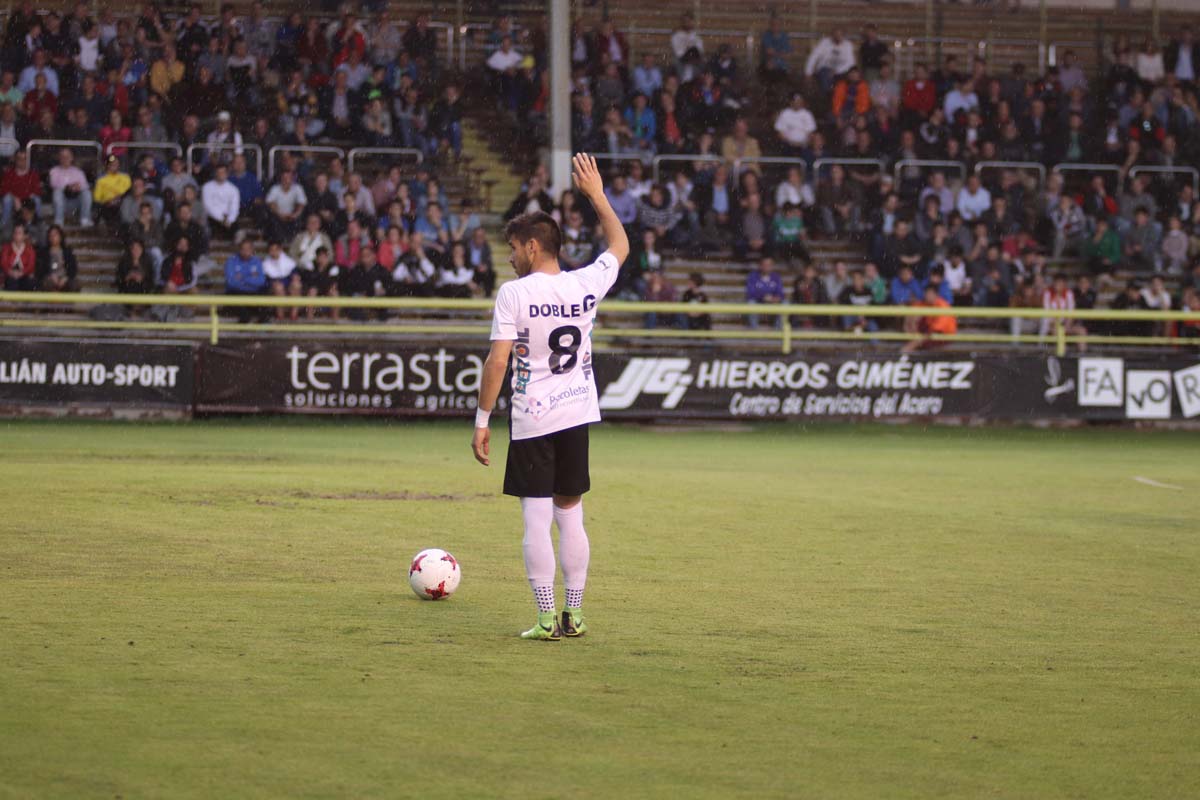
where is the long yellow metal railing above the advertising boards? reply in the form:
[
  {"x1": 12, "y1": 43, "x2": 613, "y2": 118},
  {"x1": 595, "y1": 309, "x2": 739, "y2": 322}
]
[{"x1": 0, "y1": 291, "x2": 1200, "y2": 355}]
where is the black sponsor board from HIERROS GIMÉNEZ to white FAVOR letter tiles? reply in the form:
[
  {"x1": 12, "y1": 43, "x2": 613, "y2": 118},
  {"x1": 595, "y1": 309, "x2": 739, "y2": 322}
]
[{"x1": 596, "y1": 353, "x2": 1200, "y2": 421}]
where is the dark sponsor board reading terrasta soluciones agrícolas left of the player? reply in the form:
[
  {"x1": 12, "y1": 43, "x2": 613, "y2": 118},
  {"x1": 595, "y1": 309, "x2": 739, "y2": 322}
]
[{"x1": 196, "y1": 342, "x2": 506, "y2": 416}]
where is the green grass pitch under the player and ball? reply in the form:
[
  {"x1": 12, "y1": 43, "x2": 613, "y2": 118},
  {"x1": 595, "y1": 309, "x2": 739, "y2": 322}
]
[{"x1": 0, "y1": 420, "x2": 1200, "y2": 800}]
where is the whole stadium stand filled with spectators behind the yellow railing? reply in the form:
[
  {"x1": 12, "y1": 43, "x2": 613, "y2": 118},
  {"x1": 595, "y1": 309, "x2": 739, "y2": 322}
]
[{"x1": 0, "y1": 0, "x2": 1200, "y2": 345}]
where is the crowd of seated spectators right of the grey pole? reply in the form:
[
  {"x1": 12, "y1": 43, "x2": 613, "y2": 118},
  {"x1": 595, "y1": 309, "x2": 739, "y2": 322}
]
[{"x1": 523, "y1": 14, "x2": 1200, "y2": 332}]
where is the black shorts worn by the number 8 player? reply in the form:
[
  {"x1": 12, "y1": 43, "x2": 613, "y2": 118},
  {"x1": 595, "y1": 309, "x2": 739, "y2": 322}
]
[{"x1": 504, "y1": 425, "x2": 592, "y2": 498}]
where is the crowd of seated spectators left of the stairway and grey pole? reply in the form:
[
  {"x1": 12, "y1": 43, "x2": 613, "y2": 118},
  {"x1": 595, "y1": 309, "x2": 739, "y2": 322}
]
[{"x1": 0, "y1": 1, "x2": 494, "y2": 318}]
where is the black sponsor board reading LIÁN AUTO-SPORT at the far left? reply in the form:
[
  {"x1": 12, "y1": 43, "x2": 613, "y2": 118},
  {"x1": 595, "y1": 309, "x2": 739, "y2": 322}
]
[{"x1": 0, "y1": 338, "x2": 194, "y2": 411}]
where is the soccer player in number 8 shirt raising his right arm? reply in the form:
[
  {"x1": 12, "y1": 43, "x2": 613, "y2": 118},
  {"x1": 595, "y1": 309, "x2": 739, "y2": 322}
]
[{"x1": 472, "y1": 154, "x2": 629, "y2": 642}]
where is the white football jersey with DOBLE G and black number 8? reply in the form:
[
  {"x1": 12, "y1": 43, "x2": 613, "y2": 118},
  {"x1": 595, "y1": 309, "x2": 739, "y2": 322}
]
[{"x1": 492, "y1": 251, "x2": 620, "y2": 440}]
